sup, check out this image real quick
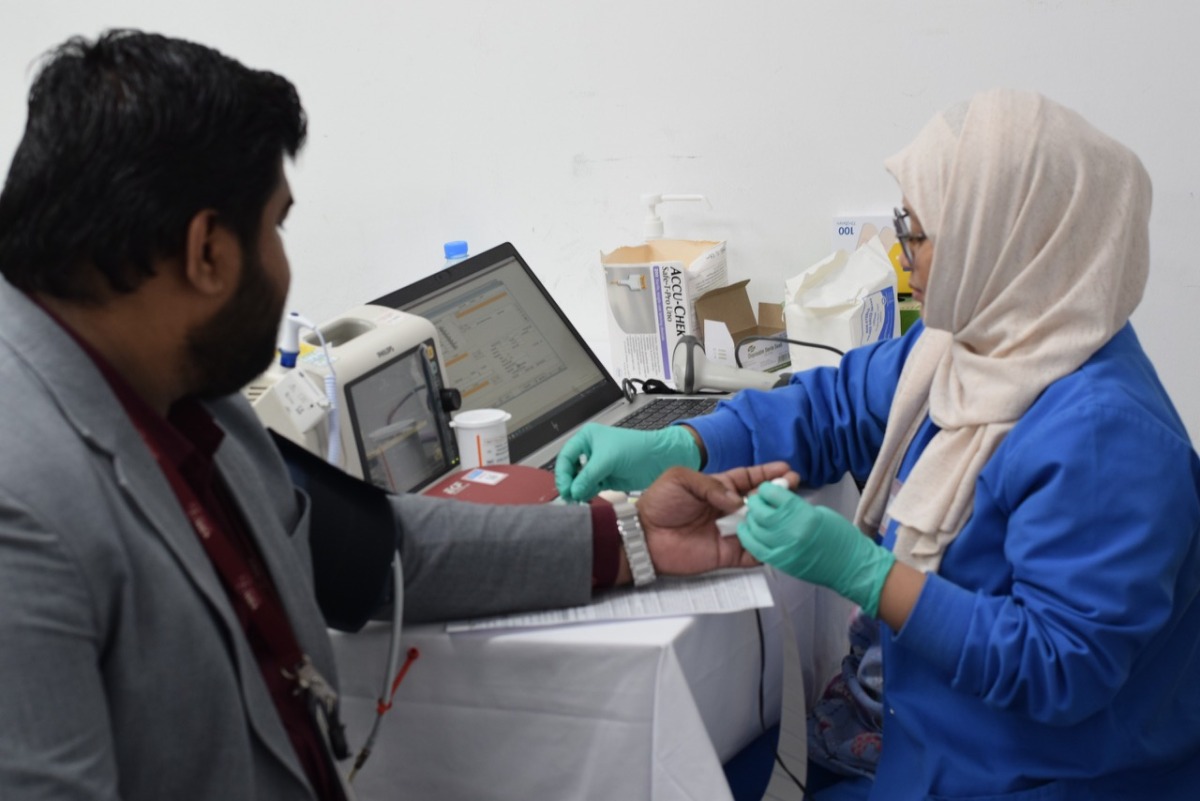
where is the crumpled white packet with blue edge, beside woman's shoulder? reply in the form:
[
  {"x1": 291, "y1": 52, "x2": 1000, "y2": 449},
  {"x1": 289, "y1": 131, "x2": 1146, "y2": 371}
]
[{"x1": 784, "y1": 236, "x2": 900, "y2": 372}]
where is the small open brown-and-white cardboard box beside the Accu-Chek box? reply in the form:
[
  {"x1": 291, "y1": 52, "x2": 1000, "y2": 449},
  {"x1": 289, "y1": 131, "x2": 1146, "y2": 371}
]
[{"x1": 696, "y1": 279, "x2": 791, "y2": 372}]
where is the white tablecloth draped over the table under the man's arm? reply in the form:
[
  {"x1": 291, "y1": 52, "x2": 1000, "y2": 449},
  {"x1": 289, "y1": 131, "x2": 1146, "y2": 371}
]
[{"x1": 334, "y1": 482, "x2": 850, "y2": 801}]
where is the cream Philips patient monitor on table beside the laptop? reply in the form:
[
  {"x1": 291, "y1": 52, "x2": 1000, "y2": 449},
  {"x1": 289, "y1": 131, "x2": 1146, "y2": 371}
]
[{"x1": 244, "y1": 306, "x2": 458, "y2": 493}]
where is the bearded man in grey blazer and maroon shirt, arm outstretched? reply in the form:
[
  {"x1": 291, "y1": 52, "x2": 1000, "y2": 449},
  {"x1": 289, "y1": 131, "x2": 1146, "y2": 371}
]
[{"x1": 0, "y1": 31, "x2": 796, "y2": 801}]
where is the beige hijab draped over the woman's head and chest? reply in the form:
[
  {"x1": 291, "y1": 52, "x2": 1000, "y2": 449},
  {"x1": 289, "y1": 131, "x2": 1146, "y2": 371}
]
[{"x1": 856, "y1": 90, "x2": 1151, "y2": 572}]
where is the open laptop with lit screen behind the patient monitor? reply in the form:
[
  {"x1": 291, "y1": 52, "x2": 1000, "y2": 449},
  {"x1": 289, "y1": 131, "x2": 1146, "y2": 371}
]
[{"x1": 371, "y1": 242, "x2": 722, "y2": 470}]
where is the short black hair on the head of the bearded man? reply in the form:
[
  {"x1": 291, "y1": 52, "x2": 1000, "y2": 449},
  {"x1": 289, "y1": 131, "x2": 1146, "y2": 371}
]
[{"x1": 0, "y1": 31, "x2": 306, "y2": 301}]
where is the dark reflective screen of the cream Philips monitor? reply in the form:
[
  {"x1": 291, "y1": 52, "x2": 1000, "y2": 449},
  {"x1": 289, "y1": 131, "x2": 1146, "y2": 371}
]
[{"x1": 346, "y1": 345, "x2": 457, "y2": 493}]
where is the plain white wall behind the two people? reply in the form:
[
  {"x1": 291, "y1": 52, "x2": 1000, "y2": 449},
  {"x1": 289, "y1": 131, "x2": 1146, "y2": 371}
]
[{"x1": 7, "y1": 0, "x2": 1200, "y2": 440}]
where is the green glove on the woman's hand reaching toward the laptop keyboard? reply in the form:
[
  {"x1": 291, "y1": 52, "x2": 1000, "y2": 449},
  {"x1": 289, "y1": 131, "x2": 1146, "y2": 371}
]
[{"x1": 554, "y1": 423, "x2": 700, "y2": 501}]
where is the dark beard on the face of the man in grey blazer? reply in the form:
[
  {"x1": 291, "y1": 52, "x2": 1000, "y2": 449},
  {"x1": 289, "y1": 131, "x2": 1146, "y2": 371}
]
[{"x1": 187, "y1": 247, "x2": 286, "y2": 398}]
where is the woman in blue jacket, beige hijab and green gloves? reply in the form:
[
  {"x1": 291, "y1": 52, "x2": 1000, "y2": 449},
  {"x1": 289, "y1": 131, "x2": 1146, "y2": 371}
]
[{"x1": 557, "y1": 91, "x2": 1200, "y2": 801}]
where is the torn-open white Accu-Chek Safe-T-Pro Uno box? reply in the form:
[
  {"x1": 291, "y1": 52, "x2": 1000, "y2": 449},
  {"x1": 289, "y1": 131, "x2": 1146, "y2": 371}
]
[{"x1": 600, "y1": 240, "x2": 728, "y2": 384}]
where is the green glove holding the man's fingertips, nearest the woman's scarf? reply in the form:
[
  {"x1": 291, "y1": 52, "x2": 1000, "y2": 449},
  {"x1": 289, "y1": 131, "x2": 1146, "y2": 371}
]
[{"x1": 738, "y1": 482, "x2": 895, "y2": 618}]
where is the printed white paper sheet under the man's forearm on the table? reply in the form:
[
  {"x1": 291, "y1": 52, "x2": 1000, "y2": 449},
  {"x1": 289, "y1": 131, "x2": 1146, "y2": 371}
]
[{"x1": 446, "y1": 568, "x2": 775, "y2": 633}]
